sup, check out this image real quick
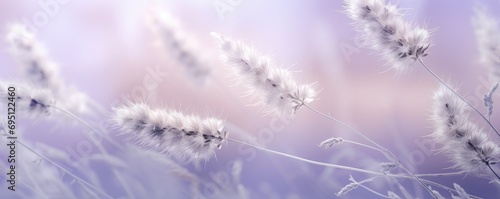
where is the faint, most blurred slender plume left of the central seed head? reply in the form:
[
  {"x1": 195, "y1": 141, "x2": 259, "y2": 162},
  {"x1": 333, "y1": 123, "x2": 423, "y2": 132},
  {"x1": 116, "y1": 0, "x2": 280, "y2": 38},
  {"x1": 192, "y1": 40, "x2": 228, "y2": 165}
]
[{"x1": 149, "y1": 11, "x2": 211, "y2": 83}]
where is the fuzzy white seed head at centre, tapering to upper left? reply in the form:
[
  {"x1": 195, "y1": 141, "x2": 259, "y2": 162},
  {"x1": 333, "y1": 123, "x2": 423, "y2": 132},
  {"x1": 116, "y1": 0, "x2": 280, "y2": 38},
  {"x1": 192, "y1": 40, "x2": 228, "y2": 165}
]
[{"x1": 212, "y1": 33, "x2": 316, "y2": 116}]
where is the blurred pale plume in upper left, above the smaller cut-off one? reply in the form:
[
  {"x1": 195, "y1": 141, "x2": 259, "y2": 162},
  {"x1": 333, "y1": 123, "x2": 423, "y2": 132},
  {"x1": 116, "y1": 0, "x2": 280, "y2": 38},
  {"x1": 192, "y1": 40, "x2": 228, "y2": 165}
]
[{"x1": 6, "y1": 24, "x2": 89, "y2": 113}]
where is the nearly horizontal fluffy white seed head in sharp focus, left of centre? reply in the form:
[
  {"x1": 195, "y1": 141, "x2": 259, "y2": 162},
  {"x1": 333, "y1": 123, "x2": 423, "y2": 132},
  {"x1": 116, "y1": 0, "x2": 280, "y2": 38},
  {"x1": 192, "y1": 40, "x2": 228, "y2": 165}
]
[{"x1": 112, "y1": 103, "x2": 227, "y2": 161}]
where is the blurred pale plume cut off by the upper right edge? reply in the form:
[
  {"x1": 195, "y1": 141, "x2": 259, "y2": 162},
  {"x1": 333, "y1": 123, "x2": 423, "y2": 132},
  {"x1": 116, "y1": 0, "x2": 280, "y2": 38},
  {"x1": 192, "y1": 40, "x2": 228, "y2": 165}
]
[{"x1": 472, "y1": 5, "x2": 500, "y2": 81}]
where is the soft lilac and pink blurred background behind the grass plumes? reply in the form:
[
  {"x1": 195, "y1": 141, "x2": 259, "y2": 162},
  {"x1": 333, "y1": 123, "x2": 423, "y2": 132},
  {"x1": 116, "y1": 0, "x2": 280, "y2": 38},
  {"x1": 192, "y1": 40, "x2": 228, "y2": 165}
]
[{"x1": 0, "y1": 0, "x2": 500, "y2": 199}]
